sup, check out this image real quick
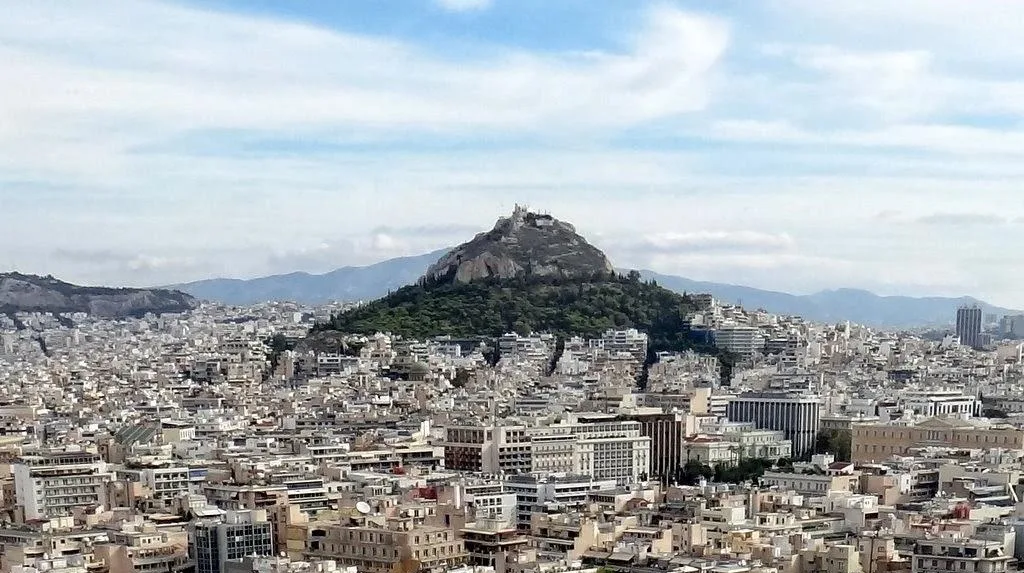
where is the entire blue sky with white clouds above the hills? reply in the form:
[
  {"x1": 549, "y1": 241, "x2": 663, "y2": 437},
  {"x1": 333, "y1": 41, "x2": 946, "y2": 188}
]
[{"x1": 0, "y1": 0, "x2": 1024, "y2": 308}]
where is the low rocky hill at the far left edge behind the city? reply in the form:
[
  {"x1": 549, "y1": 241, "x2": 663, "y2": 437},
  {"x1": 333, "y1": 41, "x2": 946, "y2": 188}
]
[{"x1": 0, "y1": 272, "x2": 199, "y2": 318}]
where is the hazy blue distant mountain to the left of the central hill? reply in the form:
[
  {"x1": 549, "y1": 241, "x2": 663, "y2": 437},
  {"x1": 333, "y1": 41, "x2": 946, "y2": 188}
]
[{"x1": 170, "y1": 249, "x2": 449, "y2": 305}]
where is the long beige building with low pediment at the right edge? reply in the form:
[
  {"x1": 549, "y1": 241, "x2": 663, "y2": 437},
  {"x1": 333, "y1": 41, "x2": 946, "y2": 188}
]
[{"x1": 850, "y1": 417, "x2": 1024, "y2": 461}]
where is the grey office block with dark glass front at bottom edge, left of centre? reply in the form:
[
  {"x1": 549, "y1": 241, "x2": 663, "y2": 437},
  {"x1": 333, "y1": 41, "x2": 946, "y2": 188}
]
[{"x1": 188, "y1": 510, "x2": 273, "y2": 573}]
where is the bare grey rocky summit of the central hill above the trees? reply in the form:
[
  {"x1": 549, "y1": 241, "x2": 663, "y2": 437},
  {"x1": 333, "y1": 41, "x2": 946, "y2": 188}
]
[{"x1": 425, "y1": 206, "x2": 614, "y2": 282}]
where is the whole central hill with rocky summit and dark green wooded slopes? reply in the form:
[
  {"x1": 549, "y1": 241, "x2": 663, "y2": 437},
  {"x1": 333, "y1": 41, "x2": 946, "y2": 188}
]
[{"x1": 310, "y1": 207, "x2": 731, "y2": 376}]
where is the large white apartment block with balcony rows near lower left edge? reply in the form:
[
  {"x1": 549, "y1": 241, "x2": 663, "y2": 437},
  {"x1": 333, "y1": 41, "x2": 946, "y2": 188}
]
[{"x1": 11, "y1": 451, "x2": 114, "y2": 520}]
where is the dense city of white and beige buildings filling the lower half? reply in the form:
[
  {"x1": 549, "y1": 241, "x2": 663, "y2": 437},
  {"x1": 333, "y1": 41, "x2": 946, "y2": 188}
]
[{"x1": 0, "y1": 297, "x2": 1024, "y2": 573}]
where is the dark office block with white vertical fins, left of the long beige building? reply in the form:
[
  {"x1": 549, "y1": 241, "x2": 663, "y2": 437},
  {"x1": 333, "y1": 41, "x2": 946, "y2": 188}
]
[{"x1": 726, "y1": 392, "x2": 821, "y2": 457}]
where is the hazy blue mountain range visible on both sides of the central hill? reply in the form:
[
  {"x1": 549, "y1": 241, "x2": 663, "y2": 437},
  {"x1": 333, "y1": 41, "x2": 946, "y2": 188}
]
[{"x1": 169, "y1": 249, "x2": 1019, "y2": 328}]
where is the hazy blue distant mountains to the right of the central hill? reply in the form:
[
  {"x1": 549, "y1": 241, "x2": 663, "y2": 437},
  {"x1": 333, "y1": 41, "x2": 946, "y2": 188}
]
[{"x1": 640, "y1": 270, "x2": 1019, "y2": 328}]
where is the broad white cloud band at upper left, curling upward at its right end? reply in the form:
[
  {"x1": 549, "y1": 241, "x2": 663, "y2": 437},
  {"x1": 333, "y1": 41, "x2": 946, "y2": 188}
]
[{"x1": 0, "y1": 1, "x2": 729, "y2": 182}]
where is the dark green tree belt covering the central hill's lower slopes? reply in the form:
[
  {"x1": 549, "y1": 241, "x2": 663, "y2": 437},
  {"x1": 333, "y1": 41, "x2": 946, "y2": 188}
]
[{"x1": 313, "y1": 272, "x2": 735, "y2": 378}]
